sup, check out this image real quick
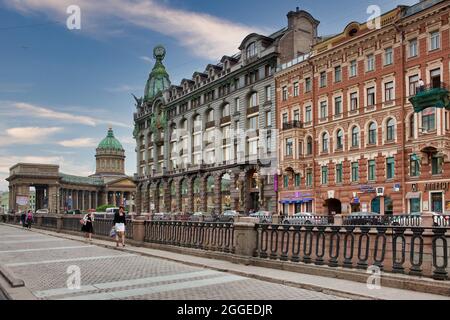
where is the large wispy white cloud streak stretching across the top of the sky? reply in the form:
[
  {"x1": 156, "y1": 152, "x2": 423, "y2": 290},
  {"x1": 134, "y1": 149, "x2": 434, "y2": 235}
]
[{"x1": 5, "y1": 0, "x2": 262, "y2": 59}]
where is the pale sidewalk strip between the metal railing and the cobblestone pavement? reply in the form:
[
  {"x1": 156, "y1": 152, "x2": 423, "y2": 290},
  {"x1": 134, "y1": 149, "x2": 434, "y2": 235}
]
[{"x1": 4, "y1": 225, "x2": 450, "y2": 300}]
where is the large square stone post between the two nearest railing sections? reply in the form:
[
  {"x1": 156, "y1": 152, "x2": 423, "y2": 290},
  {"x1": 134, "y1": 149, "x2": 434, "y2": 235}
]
[{"x1": 230, "y1": 217, "x2": 259, "y2": 257}]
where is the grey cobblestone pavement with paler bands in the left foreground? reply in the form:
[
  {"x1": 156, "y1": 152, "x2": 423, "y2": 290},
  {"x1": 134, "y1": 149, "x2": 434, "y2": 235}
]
[{"x1": 0, "y1": 225, "x2": 341, "y2": 300}]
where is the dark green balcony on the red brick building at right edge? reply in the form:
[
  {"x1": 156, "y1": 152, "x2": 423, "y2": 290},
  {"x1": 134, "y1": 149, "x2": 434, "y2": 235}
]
[{"x1": 409, "y1": 83, "x2": 450, "y2": 113}]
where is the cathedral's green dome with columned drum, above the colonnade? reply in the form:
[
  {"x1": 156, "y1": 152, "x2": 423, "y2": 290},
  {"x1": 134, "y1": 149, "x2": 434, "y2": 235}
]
[{"x1": 95, "y1": 128, "x2": 125, "y2": 176}]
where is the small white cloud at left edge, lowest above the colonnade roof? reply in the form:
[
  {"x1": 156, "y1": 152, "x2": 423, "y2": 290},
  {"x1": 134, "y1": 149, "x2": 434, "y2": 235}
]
[{"x1": 0, "y1": 127, "x2": 63, "y2": 146}]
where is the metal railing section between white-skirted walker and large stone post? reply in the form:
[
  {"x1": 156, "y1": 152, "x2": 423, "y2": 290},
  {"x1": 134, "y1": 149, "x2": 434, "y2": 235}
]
[{"x1": 145, "y1": 221, "x2": 234, "y2": 253}]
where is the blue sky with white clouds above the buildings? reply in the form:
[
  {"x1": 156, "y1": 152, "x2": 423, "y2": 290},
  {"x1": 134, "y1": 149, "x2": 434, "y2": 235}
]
[{"x1": 0, "y1": 0, "x2": 418, "y2": 191}]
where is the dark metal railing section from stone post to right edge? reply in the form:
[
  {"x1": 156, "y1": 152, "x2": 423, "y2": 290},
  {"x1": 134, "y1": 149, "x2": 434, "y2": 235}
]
[{"x1": 254, "y1": 224, "x2": 450, "y2": 280}]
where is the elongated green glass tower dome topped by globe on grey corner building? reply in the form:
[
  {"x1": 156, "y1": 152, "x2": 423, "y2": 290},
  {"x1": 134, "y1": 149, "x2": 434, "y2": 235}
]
[{"x1": 144, "y1": 46, "x2": 170, "y2": 101}]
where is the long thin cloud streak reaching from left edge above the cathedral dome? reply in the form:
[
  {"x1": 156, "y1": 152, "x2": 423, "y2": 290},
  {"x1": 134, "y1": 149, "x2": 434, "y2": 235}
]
[{"x1": 0, "y1": 101, "x2": 133, "y2": 128}]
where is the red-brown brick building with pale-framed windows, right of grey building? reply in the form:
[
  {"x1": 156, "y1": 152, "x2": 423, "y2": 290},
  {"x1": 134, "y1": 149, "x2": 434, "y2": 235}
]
[{"x1": 275, "y1": 0, "x2": 450, "y2": 214}]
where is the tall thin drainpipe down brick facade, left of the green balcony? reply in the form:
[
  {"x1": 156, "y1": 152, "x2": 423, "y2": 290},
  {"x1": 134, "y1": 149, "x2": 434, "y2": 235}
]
[{"x1": 394, "y1": 24, "x2": 406, "y2": 213}]
